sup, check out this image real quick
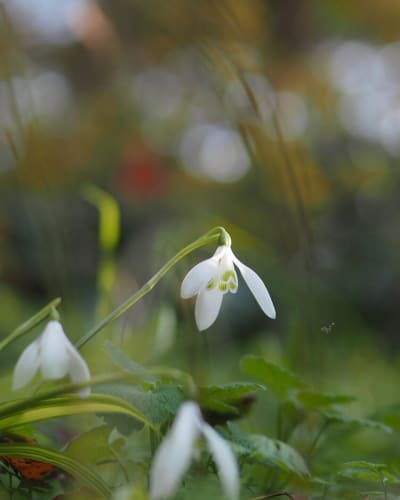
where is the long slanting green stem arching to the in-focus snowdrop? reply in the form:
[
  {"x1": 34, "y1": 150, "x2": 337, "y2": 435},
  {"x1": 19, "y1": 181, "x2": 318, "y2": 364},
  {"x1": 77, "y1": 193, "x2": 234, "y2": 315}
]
[{"x1": 75, "y1": 227, "x2": 231, "y2": 349}]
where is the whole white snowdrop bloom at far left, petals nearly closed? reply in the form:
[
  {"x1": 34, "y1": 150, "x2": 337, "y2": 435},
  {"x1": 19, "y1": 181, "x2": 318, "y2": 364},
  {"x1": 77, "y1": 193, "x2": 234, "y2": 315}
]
[{"x1": 13, "y1": 320, "x2": 90, "y2": 397}]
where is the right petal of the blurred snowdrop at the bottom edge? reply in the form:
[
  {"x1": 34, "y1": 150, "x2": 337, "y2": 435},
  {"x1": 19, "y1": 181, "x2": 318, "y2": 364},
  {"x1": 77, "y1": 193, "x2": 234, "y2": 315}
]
[{"x1": 202, "y1": 423, "x2": 239, "y2": 500}]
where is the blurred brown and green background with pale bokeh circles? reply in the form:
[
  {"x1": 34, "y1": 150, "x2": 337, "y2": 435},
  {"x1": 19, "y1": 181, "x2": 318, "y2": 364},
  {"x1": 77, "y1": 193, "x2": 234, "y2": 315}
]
[{"x1": 0, "y1": 0, "x2": 400, "y2": 422}]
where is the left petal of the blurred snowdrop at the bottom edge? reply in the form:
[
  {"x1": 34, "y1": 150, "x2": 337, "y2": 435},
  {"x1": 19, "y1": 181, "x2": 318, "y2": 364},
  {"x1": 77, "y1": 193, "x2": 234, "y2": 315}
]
[{"x1": 150, "y1": 401, "x2": 201, "y2": 500}]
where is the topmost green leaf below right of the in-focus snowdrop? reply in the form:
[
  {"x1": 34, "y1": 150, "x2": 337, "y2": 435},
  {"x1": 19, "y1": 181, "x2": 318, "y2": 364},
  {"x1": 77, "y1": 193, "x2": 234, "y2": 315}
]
[{"x1": 241, "y1": 356, "x2": 306, "y2": 400}]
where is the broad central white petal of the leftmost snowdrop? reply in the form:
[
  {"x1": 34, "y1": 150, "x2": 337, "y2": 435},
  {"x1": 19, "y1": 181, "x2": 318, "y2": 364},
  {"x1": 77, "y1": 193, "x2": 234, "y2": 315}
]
[{"x1": 40, "y1": 321, "x2": 70, "y2": 380}]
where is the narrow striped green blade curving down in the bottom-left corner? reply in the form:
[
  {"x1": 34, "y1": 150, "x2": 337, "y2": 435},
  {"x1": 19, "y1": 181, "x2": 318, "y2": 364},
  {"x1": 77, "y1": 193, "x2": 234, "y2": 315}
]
[{"x1": 0, "y1": 443, "x2": 111, "y2": 498}]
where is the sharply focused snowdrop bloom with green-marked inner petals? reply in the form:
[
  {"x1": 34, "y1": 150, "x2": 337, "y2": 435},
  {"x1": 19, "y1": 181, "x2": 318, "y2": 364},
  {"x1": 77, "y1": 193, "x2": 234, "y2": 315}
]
[{"x1": 181, "y1": 245, "x2": 276, "y2": 331}]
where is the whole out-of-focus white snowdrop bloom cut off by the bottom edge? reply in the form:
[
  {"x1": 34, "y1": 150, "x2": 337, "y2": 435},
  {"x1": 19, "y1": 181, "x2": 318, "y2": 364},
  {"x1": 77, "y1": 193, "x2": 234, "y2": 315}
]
[{"x1": 150, "y1": 401, "x2": 239, "y2": 500}]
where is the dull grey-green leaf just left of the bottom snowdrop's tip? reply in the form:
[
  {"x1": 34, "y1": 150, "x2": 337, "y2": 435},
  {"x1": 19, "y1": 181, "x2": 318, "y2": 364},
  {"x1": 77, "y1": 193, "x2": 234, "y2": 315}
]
[{"x1": 99, "y1": 384, "x2": 184, "y2": 434}]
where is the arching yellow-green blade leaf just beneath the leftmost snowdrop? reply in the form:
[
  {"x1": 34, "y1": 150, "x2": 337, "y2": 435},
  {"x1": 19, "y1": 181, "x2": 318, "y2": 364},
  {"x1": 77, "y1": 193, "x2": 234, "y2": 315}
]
[{"x1": 0, "y1": 394, "x2": 154, "y2": 430}]
